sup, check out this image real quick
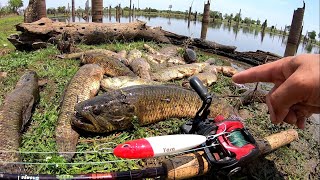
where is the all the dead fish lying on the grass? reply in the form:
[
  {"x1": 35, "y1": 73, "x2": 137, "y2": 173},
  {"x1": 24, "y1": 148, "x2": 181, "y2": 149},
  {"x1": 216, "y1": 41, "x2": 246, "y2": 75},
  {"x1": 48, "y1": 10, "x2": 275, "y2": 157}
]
[{"x1": 0, "y1": 44, "x2": 240, "y2": 166}]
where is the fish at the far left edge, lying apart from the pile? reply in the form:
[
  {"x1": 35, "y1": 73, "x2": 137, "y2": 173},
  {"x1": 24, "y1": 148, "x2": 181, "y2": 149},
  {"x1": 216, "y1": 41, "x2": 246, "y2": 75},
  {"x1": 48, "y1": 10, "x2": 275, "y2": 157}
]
[{"x1": 0, "y1": 71, "x2": 39, "y2": 173}]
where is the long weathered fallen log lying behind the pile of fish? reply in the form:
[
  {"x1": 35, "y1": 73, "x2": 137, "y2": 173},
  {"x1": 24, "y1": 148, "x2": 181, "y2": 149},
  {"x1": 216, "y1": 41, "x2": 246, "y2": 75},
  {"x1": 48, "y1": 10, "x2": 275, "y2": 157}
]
[{"x1": 8, "y1": 18, "x2": 236, "y2": 53}]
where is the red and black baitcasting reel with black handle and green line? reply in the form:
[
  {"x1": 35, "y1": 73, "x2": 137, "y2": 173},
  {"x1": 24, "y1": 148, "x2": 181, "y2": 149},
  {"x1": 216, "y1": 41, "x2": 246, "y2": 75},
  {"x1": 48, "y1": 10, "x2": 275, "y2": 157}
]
[{"x1": 181, "y1": 77, "x2": 259, "y2": 174}]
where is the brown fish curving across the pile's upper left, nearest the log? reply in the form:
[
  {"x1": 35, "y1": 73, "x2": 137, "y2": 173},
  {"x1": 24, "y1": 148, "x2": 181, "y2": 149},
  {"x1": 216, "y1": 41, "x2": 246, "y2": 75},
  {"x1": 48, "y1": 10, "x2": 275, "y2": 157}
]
[{"x1": 81, "y1": 53, "x2": 136, "y2": 77}]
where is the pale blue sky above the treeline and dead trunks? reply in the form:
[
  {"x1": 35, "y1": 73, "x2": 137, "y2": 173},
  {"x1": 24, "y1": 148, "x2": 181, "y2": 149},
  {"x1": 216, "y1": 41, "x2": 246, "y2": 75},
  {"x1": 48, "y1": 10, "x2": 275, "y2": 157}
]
[{"x1": 0, "y1": 0, "x2": 320, "y2": 34}]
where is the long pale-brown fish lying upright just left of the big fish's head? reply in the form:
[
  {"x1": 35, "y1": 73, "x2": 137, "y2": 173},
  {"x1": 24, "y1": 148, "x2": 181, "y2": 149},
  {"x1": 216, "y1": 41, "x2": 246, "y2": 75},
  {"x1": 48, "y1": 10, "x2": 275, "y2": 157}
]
[{"x1": 55, "y1": 64, "x2": 104, "y2": 160}]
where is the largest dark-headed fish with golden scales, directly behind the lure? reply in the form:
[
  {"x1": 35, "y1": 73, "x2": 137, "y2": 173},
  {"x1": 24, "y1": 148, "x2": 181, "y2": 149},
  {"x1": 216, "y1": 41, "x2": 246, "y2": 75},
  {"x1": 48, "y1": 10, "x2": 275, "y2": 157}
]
[{"x1": 72, "y1": 85, "x2": 233, "y2": 133}]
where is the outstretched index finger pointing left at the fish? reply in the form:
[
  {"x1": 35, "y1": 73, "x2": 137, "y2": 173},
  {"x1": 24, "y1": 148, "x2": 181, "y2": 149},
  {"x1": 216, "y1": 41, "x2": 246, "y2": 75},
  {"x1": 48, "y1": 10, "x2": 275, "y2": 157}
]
[{"x1": 232, "y1": 57, "x2": 292, "y2": 84}]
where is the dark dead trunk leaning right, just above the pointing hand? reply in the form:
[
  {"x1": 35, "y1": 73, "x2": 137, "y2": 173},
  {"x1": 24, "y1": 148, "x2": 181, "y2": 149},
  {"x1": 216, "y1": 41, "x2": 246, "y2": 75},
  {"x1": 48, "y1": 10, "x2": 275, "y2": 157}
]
[{"x1": 284, "y1": 3, "x2": 305, "y2": 56}]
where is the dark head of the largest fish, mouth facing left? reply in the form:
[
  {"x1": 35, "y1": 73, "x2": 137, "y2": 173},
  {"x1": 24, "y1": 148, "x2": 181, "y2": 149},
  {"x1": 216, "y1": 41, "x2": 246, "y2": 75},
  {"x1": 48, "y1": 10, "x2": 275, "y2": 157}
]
[{"x1": 73, "y1": 93, "x2": 135, "y2": 133}]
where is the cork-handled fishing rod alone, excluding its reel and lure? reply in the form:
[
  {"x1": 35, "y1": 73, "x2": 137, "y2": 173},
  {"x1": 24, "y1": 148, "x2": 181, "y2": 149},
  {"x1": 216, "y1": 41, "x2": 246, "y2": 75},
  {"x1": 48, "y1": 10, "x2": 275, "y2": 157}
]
[{"x1": 0, "y1": 129, "x2": 298, "y2": 180}]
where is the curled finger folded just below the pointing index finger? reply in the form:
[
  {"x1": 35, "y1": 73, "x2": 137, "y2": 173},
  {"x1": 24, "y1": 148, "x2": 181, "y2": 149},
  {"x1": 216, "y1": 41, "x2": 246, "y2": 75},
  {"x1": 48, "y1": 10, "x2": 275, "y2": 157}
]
[{"x1": 269, "y1": 74, "x2": 305, "y2": 123}]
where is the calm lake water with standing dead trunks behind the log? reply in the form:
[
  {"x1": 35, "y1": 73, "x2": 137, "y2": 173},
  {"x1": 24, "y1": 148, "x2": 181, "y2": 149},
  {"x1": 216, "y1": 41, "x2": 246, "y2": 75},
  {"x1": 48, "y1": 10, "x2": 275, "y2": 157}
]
[{"x1": 52, "y1": 16, "x2": 320, "y2": 56}]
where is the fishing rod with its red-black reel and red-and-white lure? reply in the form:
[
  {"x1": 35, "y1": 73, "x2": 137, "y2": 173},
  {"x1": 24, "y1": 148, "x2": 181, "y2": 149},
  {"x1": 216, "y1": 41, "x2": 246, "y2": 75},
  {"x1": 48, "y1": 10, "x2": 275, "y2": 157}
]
[{"x1": 0, "y1": 78, "x2": 298, "y2": 179}]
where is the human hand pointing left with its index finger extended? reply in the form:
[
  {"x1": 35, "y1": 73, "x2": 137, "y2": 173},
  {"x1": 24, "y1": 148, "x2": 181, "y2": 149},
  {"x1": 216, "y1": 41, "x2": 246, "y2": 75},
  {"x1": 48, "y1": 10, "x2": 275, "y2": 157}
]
[{"x1": 232, "y1": 54, "x2": 320, "y2": 129}]
